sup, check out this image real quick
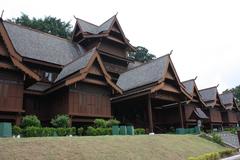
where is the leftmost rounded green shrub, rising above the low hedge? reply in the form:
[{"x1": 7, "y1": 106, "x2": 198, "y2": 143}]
[{"x1": 22, "y1": 115, "x2": 41, "y2": 128}]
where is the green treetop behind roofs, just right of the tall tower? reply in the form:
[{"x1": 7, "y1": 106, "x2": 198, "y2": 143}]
[{"x1": 129, "y1": 46, "x2": 156, "y2": 62}]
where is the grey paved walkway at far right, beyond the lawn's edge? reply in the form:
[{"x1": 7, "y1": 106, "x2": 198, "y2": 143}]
[{"x1": 219, "y1": 132, "x2": 240, "y2": 148}]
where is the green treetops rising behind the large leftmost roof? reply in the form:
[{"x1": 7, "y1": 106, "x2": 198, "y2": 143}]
[{"x1": 9, "y1": 13, "x2": 72, "y2": 38}]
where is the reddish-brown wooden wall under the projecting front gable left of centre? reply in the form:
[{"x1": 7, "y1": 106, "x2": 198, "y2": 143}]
[{"x1": 69, "y1": 83, "x2": 111, "y2": 117}]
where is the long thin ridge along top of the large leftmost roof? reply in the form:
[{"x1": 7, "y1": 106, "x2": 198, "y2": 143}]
[{"x1": 3, "y1": 20, "x2": 72, "y2": 43}]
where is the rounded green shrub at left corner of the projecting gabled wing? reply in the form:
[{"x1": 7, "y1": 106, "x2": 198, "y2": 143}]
[{"x1": 51, "y1": 115, "x2": 70, "y2": 128}]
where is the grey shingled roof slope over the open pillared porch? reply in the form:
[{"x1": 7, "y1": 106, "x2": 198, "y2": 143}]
[{"x1": 117, "y1": 55, "x2": 170, "y2": 91}]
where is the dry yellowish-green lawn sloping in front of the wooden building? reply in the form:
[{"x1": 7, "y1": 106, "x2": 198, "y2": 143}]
[{"x1": 0, "y1": 134, "x2": 229, "y2": 160}]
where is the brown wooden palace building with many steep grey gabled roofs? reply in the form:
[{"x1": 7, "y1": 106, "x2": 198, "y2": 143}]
[{"x1": 0, "y1": 16, "x2": 238, "y2": 133}]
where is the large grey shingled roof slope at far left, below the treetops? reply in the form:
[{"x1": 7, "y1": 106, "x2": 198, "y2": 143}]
[{"x1": 3, "y1": 22, "x2": 80, "y2": 65}]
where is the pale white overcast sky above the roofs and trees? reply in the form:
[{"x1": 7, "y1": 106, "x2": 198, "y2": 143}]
[{"x1": 0, "y1": 0, "x2": 240, "y2": 91}]
